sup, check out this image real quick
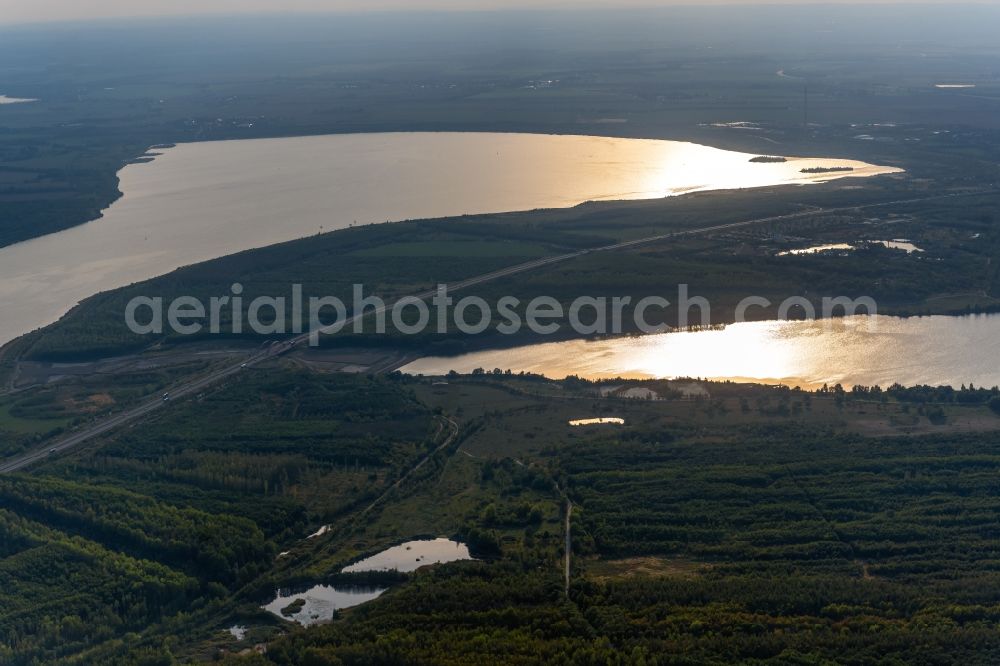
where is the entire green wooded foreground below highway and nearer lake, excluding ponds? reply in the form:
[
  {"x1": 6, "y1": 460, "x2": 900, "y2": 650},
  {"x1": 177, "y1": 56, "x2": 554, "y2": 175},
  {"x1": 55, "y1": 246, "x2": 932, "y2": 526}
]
[{"x1": 0, "y1": 367, "x2": 1000, "y2": 665}]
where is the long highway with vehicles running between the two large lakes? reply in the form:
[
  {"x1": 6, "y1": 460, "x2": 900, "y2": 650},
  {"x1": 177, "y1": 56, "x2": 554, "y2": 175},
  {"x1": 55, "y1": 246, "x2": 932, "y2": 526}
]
[{"x1": 0, "y1": 190, "x2": 997, "y2": 474}]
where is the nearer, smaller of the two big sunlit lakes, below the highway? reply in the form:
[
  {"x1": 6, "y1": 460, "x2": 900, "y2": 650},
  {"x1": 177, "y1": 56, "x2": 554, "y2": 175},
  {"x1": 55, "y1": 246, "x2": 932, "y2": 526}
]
[{"x1": 403, "y1": 315, "x2": 1000, "y2": 388}]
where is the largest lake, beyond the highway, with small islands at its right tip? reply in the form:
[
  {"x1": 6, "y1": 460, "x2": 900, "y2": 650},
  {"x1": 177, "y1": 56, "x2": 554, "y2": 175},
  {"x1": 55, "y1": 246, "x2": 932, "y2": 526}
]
[{"x1": 0, "y1": 133, "x2": 898, "y2": 344}]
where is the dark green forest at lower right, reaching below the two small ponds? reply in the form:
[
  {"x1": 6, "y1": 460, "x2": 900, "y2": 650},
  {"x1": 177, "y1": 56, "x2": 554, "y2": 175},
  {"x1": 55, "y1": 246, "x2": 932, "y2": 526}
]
[{"x1": 225, "y1": 400, "x2": 1000, "y2": 664}]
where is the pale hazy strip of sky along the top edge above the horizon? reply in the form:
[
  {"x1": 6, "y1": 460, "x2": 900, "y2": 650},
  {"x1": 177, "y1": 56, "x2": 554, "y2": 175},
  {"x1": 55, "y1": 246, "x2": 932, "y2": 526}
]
[{"x1": 0, "y1": 0, "x2": 984, "y2": 23}]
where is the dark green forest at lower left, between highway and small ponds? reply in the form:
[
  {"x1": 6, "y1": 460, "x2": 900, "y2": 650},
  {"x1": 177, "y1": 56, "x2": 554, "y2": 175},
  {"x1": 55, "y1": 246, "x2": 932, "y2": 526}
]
[{"x1": 0, "y1": 370, "x2": 446, "y2": 664}]
